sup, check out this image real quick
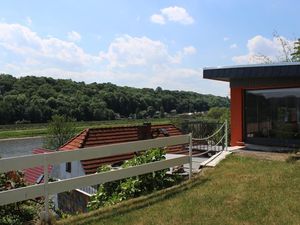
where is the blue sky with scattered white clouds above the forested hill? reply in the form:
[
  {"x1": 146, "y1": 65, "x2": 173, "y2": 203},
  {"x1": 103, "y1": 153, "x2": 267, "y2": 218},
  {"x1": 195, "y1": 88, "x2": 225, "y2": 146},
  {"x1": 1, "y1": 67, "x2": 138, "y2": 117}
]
[{"x1": 0, "y1": 0, "x2": 300, "y2": 96}]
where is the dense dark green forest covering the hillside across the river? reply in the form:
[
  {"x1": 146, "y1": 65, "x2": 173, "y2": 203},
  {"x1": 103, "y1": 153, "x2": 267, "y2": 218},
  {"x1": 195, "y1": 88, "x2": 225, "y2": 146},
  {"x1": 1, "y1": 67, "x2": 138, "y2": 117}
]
[{"x1": 0, "y1": 74, "x2": 229, "y2": 124}]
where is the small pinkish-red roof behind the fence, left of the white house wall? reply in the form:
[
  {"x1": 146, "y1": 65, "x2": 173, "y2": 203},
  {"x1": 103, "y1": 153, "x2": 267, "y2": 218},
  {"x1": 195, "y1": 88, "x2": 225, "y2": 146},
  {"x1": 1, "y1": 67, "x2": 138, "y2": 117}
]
[{"x1": 24, "y1": 148, "x2": 53, "y2": 184}]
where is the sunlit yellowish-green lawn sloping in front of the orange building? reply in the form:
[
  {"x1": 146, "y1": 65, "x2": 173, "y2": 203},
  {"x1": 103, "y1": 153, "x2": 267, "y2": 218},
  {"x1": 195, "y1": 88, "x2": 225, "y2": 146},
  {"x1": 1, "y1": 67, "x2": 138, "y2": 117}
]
[{"x1": 59, "y1": 155, "x2": 300, "y2": 225}]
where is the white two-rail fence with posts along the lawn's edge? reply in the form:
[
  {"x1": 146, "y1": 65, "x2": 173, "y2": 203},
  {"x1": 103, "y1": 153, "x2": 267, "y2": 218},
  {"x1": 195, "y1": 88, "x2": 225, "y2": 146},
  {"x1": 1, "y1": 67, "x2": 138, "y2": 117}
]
[{"x1": 0, "y1": 134, "x2": 192, "y2": 220}]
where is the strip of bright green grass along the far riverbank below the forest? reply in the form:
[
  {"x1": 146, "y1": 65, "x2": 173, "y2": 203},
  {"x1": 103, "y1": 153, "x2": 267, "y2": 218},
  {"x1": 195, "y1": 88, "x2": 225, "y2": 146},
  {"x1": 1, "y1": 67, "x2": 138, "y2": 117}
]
[{"x1": 0, "y1": 119, "x2": 170, "y2": 139}]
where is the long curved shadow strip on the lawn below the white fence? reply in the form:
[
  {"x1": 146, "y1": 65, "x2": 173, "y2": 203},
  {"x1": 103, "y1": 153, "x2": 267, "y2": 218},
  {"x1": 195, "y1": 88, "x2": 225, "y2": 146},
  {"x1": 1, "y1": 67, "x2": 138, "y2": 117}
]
[{"x1": 57, "y1": 176, "x2": 210, "y2": 225}]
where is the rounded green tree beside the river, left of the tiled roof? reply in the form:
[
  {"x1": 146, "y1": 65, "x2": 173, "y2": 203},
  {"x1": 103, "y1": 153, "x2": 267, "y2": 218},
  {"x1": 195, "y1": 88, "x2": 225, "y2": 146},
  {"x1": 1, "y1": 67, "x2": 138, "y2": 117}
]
[{"x1": 44, "y1": 115, "x2": 76, "y2": 150}]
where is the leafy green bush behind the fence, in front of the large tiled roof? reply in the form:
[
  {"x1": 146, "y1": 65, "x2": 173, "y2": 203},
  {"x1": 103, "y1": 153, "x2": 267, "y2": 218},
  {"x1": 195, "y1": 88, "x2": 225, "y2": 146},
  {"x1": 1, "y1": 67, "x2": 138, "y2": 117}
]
[{"x1": 88, "y1": 148, "x2": 182, "y2": 210}]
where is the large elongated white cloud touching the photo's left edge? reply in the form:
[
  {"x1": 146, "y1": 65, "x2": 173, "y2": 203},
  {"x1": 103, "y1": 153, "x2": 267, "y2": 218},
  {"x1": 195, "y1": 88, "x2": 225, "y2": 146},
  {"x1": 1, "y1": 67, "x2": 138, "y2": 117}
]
[{"x1": 0, "y1": 23, "x2": 100, "y2": 69}]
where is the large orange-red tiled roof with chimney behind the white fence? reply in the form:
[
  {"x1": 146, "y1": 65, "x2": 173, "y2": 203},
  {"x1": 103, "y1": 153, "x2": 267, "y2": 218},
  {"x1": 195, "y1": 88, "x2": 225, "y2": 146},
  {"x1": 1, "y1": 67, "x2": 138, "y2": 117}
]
[{"x1": 60, "y1": 124, "x2": 186, "y2": 174}]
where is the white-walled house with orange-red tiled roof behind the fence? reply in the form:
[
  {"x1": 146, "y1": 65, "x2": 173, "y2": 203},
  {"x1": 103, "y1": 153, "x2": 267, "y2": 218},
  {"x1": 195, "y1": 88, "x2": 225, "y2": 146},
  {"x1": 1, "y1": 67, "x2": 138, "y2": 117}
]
[{"x1": 53, "y1": 123, "x2": 188, "y2": 212}]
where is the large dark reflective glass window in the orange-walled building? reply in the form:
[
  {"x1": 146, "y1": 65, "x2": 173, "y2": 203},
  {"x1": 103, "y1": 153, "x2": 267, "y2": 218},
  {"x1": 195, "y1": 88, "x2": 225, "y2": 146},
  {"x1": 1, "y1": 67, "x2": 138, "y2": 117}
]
[{"x1": 244, "y1": 88, "x2": 300, "y2": 143}]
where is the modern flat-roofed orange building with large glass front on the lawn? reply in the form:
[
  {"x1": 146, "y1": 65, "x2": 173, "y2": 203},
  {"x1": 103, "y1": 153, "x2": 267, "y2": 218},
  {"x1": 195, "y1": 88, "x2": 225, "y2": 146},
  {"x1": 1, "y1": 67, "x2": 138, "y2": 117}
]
[{"x1": 203, "y1": 63, "x2": 300, "y2": 148}]
